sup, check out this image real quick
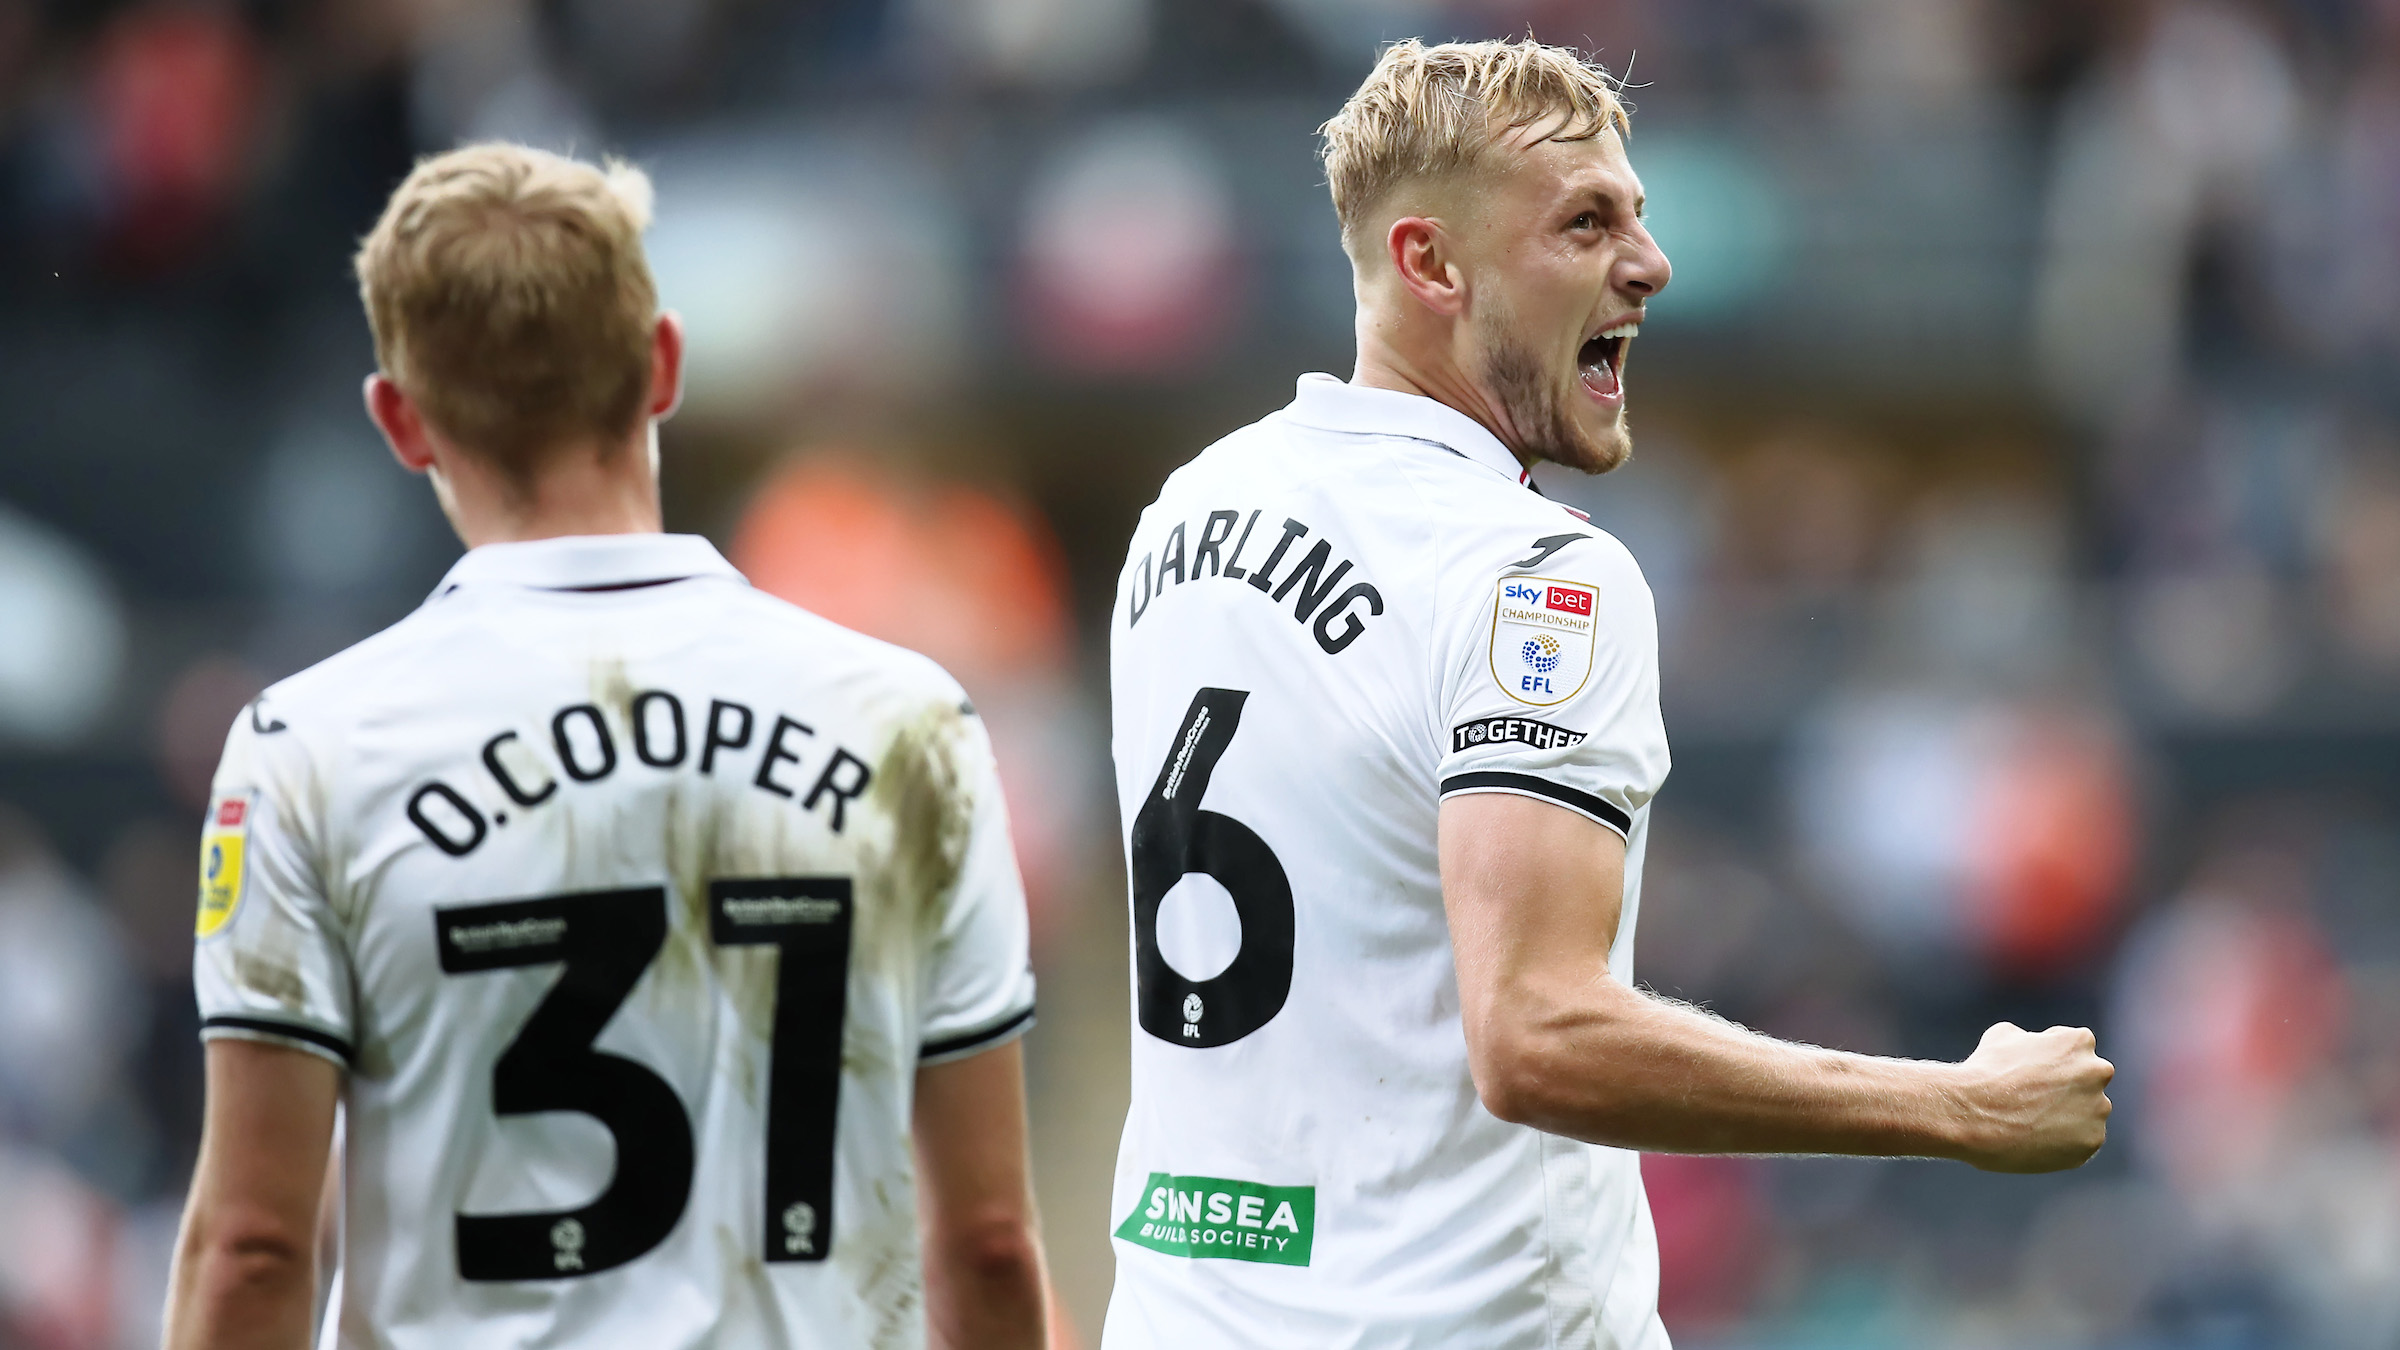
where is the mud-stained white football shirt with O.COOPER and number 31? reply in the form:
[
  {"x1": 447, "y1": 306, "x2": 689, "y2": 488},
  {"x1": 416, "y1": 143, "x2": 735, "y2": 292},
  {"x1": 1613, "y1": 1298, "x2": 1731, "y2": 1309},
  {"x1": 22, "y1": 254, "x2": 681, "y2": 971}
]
[{"x1": 194, "y1": 536, "x2": 1034, "y2": 1350}]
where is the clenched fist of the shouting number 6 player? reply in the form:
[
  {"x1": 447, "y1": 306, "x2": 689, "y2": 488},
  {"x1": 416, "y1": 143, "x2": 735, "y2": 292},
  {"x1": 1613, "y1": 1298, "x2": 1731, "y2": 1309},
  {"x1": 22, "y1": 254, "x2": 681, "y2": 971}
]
[{"x1": 1958, "y1": 1021, "x2": 2117, "y2": 1172}]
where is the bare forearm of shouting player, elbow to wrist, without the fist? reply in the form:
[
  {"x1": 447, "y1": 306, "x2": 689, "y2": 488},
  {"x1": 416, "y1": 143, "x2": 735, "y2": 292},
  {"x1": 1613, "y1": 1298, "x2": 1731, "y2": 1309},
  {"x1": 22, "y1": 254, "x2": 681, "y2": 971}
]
[{"x1": 1478, "y1": 980, "x2": 1978, "y2": 1158}]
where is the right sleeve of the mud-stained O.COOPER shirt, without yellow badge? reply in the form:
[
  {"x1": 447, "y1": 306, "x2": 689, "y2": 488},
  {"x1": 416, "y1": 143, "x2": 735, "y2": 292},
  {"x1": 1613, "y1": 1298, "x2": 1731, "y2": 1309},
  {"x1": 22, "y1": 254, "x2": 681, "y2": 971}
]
[{"x1": 917, "y1": 716, "x2": 1034, "y2": 1064}]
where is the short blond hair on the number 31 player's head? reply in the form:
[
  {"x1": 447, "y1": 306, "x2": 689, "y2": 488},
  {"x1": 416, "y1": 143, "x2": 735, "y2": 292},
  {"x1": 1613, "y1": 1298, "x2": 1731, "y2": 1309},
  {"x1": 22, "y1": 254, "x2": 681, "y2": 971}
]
[{"x1": 358, "y1": 142, "x2": 658, "y2": 478}]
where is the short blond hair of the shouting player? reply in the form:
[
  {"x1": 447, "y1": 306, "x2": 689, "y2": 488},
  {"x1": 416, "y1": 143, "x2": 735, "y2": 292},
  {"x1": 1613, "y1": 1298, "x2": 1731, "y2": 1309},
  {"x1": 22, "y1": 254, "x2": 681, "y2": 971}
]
[{"x1": 1318, "y1": 36, "x2": 1630, "y2": 243}]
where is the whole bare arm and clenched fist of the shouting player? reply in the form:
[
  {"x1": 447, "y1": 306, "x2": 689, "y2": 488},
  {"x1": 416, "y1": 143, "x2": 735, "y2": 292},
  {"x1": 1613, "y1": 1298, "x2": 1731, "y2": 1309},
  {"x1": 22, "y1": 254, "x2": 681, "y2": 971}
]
[{"x1": 1442, "y1": 793, "x2": 2114, "y2": 1172}]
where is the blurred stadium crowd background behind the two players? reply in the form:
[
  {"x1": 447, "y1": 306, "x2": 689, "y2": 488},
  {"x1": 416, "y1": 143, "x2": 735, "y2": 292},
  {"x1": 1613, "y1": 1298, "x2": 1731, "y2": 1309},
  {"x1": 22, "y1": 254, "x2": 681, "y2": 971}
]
[{"x1": 0, "y1": 0, "x2": 2400, "y2": 1350}]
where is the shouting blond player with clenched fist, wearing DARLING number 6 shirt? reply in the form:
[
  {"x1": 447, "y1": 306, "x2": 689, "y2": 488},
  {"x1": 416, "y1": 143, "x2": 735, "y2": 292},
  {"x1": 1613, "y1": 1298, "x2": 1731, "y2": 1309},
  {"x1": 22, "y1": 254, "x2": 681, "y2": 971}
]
[{"x1": 1104, "y1": 41, "x2": 2110, "y2": 1350}]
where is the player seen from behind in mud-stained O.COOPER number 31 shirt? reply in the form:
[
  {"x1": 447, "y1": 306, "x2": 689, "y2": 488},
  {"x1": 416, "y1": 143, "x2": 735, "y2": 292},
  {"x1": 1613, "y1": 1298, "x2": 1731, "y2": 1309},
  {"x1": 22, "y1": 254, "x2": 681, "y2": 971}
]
[{"x1": 166, "y1": 144, "x2": 1044, "y2": 1350}]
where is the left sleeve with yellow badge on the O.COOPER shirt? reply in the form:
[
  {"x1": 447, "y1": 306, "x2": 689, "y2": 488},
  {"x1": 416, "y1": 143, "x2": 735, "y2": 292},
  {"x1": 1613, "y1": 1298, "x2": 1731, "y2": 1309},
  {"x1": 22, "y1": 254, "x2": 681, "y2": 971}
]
[{"x1": 192, "y1": 701, "x2": 358, "y2": 1067}]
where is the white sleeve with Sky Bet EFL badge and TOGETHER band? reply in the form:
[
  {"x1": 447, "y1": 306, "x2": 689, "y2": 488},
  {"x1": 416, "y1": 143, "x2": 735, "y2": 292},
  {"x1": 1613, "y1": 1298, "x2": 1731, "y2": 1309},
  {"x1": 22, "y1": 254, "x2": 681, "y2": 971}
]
[{"x1": 1435, "y1": 531, "x2": 1668, "y2": 834}]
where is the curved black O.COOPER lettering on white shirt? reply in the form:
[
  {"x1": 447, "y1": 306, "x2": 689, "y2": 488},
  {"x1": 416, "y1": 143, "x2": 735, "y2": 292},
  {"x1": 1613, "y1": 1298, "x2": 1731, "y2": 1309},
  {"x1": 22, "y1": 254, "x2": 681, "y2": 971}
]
[{"x1": 406, "y1": 689, "x2": 874, "y2": 858}]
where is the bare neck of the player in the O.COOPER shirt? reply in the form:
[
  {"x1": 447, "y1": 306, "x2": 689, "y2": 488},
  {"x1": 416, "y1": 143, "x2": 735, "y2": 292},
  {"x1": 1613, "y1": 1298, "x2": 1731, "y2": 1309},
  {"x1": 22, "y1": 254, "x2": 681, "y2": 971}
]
[{"x1": 434, "y1": 428, "x2": 662, "y2": 548}]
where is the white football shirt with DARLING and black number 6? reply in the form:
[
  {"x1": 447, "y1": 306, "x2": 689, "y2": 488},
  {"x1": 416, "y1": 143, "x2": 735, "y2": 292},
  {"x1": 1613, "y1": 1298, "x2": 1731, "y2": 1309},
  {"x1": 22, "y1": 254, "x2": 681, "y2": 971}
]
[{"x1": 1104, "y1": 375, "x2": 1668, "y2": 1350}]
